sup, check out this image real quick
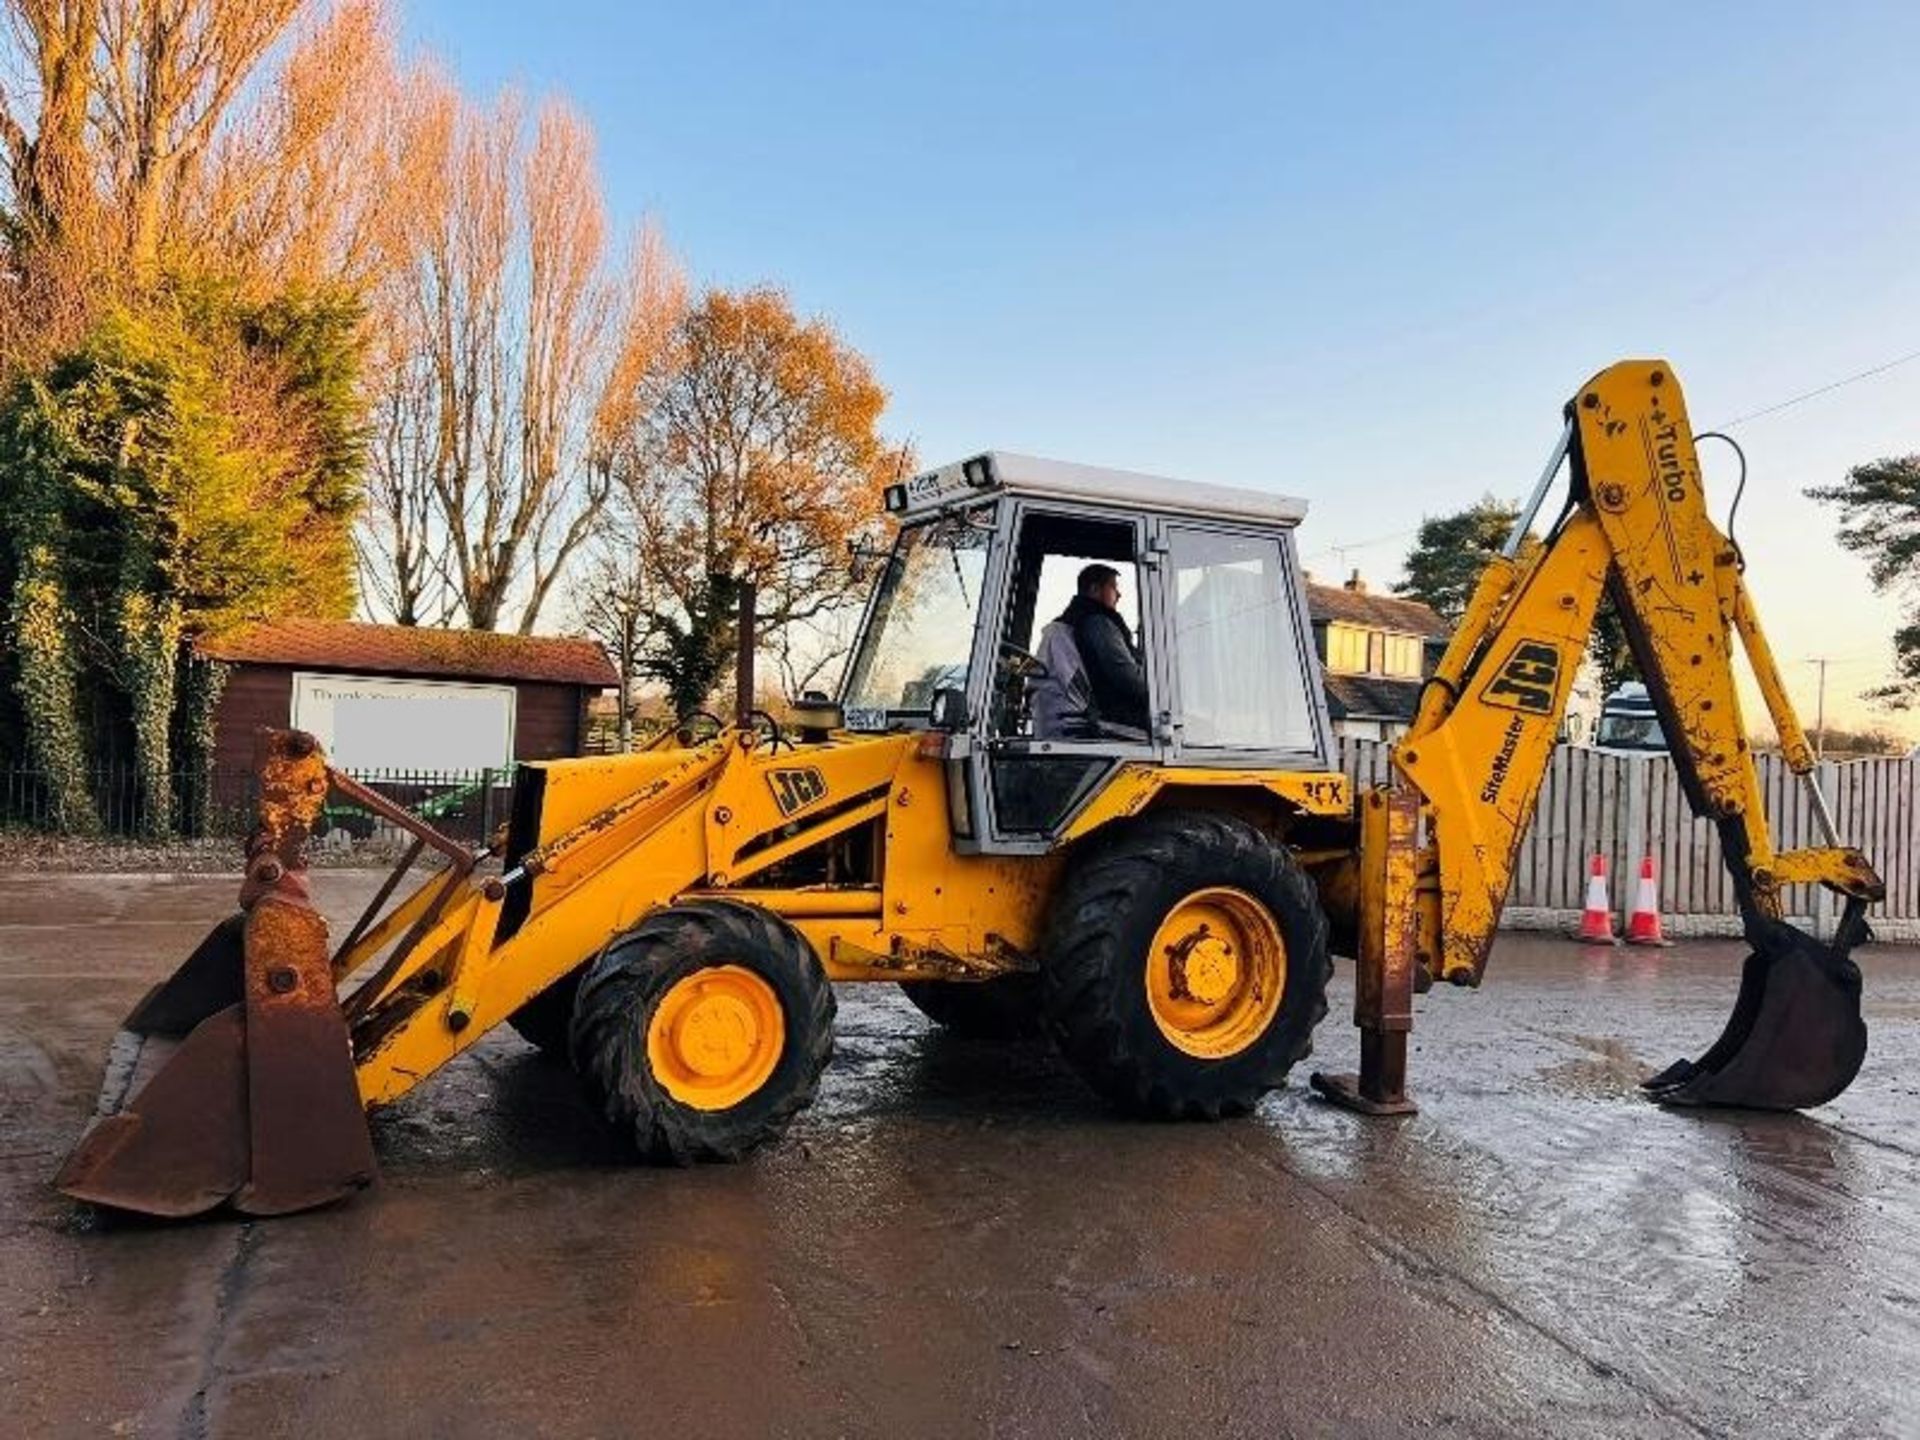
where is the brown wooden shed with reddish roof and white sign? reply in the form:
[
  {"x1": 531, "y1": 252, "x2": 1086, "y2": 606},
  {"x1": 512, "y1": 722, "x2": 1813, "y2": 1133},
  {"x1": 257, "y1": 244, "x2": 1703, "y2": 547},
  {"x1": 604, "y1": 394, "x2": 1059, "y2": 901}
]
[{"x1": 192, "y1": 620, "x2": 616, "y2": 774}]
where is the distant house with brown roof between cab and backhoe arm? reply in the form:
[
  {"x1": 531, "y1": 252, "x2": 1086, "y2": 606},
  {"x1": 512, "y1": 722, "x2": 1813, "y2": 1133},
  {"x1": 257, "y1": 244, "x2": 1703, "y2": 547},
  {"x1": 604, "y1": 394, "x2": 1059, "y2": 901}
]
[{"x1": 1308, "y1": 570, "x2": 1450, "y2": 739}]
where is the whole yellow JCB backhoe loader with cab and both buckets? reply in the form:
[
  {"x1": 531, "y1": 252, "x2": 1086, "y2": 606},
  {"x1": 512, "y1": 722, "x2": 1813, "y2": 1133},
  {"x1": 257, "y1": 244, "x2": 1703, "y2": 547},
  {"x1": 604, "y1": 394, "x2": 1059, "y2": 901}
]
[{"x1": 58, "y1": 361, "x2": 1882, "y2": 1215}]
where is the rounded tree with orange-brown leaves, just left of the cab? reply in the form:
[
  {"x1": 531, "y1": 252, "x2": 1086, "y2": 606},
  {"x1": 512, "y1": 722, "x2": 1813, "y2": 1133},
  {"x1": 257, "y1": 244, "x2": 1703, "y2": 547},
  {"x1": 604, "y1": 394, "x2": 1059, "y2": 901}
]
[{"x1": 606, "y1": 288, "x2": 910, "y2": 714}]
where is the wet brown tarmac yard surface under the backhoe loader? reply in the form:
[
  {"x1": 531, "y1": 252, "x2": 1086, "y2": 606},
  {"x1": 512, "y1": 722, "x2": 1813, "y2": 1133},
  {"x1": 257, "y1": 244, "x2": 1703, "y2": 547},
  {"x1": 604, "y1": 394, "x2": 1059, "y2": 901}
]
[{"x1": 0, "y1": 876, "x2": 1920, "y2": 1440}]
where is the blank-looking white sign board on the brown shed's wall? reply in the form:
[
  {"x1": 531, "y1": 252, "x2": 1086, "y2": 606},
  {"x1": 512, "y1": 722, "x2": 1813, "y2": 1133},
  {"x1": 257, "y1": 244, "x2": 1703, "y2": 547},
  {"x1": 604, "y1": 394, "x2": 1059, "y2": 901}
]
[{"x1": 294, "y1": 670, "x2": 515, "y2": 772}]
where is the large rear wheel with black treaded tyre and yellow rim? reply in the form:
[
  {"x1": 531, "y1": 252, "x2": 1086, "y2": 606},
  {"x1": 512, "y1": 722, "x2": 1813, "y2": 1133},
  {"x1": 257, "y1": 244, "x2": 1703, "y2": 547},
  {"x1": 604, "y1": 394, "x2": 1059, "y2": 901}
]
[{"x1": 1041, "y1": 810, "x2": 1332, "y2": 1119}]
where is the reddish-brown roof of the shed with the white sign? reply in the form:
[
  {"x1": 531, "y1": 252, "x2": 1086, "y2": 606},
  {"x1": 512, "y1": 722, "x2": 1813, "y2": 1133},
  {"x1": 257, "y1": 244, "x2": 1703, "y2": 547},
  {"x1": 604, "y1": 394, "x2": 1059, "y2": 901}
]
[{"x1": 194, "y1": 620, "x2": 618, "y2": 687}]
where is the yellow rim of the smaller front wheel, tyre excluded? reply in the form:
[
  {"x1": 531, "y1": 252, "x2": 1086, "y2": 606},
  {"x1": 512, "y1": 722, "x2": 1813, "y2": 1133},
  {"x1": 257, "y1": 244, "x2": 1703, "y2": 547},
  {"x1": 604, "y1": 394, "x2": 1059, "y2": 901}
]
[{"x1": 647, "y1": 966, "x2": 787, "y2": 1110}]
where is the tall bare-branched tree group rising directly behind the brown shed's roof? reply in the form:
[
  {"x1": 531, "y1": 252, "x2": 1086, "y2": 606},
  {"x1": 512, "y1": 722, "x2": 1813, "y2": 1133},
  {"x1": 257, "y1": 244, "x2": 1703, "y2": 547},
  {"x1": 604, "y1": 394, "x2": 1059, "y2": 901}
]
[{"x1": 361, "y1": 81, "x2": 682, "y2": 634}]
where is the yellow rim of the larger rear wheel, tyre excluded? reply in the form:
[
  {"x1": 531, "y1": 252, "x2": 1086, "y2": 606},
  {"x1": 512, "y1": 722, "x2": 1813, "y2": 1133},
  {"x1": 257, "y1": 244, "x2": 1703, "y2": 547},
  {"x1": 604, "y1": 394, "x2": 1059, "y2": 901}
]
[{"x1": 1146, "y1": 885, "x2": 1286, "y2": 1060}]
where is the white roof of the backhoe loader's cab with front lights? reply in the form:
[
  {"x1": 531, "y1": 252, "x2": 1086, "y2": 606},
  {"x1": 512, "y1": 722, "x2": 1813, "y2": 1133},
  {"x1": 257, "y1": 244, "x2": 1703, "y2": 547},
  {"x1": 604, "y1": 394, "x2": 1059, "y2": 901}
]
[{"x1": 887, "y1": 449, "x2": 1308, "y2": 526}]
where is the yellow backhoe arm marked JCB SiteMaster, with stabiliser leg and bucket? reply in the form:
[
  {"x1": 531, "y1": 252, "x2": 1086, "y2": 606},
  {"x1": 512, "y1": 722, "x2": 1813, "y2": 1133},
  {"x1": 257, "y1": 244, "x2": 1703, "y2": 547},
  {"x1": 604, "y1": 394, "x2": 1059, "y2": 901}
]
[{"x1": 1321, "y1": 361, "x2": 1884, "y2": 1108}]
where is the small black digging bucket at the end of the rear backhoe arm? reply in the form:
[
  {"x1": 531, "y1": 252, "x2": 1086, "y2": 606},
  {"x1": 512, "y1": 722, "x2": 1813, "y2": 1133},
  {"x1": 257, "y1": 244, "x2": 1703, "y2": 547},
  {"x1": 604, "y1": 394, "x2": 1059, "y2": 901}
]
[{"x1": 1642, "y1": 906, "x2": 1866, "y2": 1110}]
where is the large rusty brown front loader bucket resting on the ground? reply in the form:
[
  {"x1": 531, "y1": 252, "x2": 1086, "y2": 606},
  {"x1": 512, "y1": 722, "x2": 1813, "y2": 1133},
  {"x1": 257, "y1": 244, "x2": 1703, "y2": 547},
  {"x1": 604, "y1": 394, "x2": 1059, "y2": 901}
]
[{"x1": 54, "y1": 735, "x2": 374, "y2": 1215}]
